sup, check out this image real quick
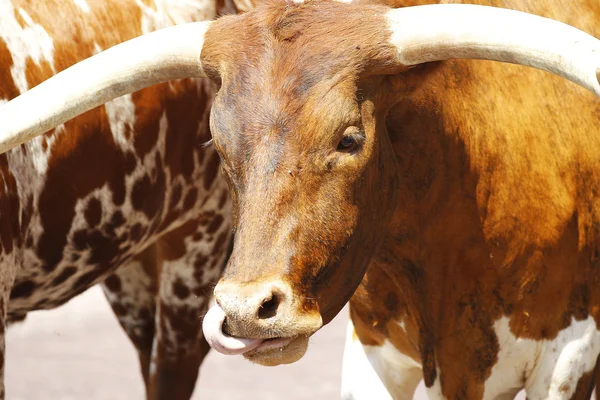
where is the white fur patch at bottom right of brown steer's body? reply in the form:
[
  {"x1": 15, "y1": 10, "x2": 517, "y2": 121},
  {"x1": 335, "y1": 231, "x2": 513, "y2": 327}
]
[{"x1": 484, "y1": 317, "x2": 600, "y2": 400}]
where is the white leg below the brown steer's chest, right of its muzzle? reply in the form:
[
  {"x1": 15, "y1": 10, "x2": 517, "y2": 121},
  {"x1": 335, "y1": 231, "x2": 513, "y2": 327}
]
[{"x1": 342, "y1": 321, "x2": 423, "y2": 400}]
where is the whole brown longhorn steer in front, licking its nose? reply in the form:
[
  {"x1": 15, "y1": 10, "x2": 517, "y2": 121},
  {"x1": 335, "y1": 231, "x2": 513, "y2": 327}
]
[{"x1": 0, "y1": 1, "x2": 600, "y2": 399}]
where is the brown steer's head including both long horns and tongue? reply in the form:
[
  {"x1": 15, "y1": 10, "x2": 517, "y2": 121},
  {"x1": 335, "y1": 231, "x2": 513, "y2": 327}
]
[{"x1": 0, "y1": 1, "x2": 600, "y2": 365}]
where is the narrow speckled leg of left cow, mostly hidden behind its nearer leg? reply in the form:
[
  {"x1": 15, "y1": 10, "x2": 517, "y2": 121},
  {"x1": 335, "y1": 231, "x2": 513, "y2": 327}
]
[{"x1": 102, "y1": 246, "x2": 158, "y2": 388}]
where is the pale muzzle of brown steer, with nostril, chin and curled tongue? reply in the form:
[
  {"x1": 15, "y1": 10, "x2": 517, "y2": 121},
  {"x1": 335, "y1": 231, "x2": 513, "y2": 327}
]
[{"x1": 202, "y1": 282, "x2": 323, "y2": 365}]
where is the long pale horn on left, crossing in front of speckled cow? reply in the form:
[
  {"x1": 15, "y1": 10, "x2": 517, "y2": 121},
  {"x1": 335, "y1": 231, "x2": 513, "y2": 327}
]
[{"x1": 0, "y1": 21, "x2": 211, "y2": 153}]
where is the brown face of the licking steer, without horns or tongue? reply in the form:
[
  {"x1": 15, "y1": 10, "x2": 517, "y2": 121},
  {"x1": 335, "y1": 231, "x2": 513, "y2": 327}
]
[{"x1": 203, "y1": 3, "x2": 403, "y2": 364}]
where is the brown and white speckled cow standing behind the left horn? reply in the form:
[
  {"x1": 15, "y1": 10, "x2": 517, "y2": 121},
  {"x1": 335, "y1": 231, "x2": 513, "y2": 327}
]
[{"x1": 0, "y1": 0, "x2": 231, "y2": 399}]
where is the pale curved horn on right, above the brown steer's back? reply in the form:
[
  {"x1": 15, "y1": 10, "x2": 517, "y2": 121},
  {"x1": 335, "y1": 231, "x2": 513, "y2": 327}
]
[{"x1": 387, "y1": 4, "x2": 600, "y2": 96}]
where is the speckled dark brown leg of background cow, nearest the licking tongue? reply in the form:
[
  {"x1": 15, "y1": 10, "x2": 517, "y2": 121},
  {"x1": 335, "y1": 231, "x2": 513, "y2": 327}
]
[{"x1": 149, "y1": 221, "x2": 231, "y2": 400}]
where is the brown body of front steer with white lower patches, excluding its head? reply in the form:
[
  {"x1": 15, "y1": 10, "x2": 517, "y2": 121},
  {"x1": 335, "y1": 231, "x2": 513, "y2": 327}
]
[{"x1": 342, "y1": 1, "x2": 600, "y2": 399}]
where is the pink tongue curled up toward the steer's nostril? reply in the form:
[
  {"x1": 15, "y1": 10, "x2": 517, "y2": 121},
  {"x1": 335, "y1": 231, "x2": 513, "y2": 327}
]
[{"x1": 202, "y1": 304, "x2": 263, "y2": 355}]
